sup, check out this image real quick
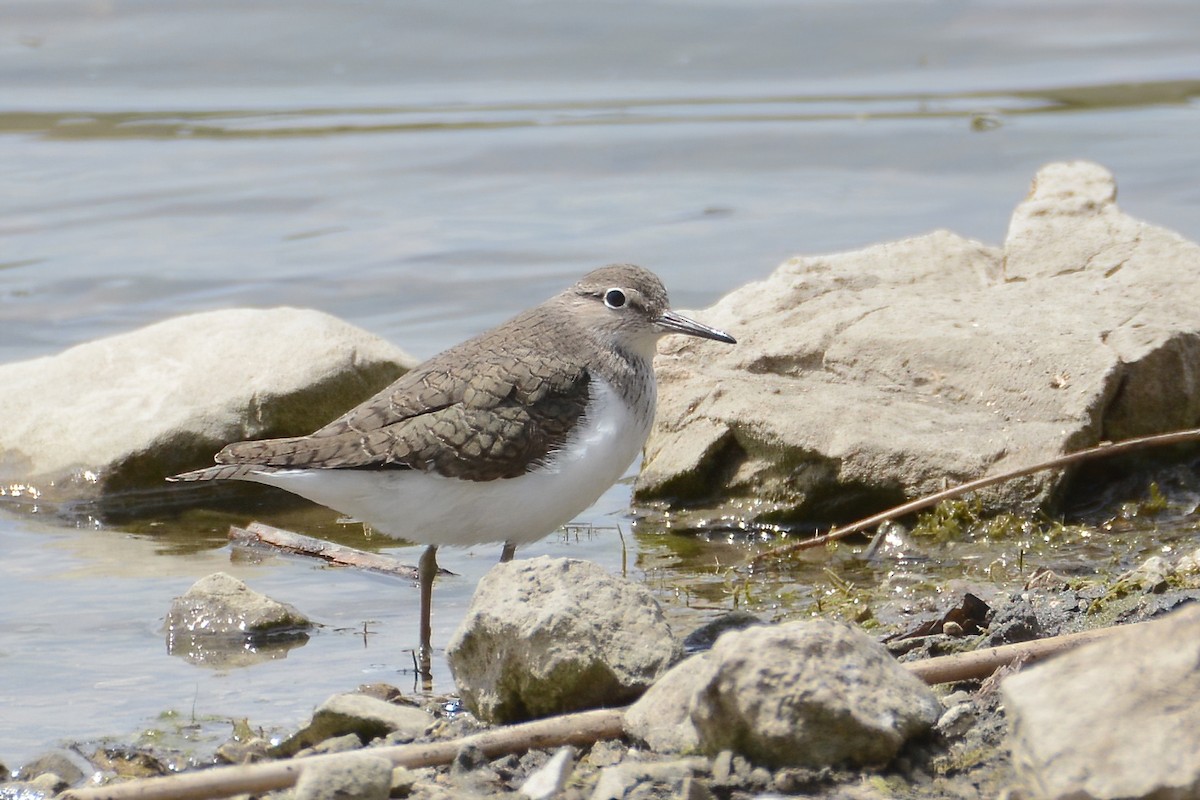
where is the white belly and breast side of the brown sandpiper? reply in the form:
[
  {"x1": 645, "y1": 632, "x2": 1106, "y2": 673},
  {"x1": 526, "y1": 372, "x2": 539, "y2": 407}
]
[{"x1": 244, "y1": 378, "x2": 653, "y2": 546}]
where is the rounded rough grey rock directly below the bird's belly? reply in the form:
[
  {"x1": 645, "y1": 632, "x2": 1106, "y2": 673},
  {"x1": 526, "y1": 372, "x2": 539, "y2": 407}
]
[{"x1": 446, "y1": 557, "x2": 680, "y2": 723}]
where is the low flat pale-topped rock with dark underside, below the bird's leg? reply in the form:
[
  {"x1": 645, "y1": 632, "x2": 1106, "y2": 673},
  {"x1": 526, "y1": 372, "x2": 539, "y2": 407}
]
[{"x1": 271, "y1": 693, "x2": 433, "y2": 756}]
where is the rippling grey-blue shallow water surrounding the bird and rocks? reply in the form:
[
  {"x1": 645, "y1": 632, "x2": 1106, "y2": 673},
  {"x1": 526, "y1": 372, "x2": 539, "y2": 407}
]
[{"x1": 0, "y1": 0, "x2": 1200, "y2": 765}]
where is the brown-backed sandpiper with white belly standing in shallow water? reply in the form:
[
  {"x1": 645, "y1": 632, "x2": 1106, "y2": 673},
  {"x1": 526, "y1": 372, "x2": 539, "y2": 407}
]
[{"x1": 168, "y1": 264, "x2": 737, "y2": 679}]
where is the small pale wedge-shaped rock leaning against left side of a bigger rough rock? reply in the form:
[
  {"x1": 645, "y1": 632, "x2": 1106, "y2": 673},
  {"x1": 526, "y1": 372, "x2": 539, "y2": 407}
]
[{"x1": 624, "y1": 652, "x2": 709, "y2": 753}]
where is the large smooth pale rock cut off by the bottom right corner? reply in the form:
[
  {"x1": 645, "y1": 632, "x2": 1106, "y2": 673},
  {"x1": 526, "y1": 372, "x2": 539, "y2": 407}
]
[{"x1": 1001, "y1": 604, "x2": 1200, "y2": 800}]
